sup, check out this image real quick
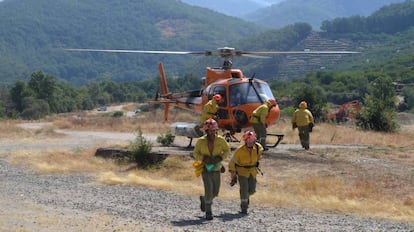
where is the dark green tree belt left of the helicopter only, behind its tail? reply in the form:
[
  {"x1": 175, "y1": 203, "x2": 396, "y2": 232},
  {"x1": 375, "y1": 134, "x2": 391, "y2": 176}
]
[{"x1": 0, "y1": 71, "x2": 201, "y2": 119}]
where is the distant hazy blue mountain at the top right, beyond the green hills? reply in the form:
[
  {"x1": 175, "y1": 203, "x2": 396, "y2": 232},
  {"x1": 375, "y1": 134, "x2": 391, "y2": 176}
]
[{"x1": 243, "y1": 0, "x2": 405, "y2": 30}]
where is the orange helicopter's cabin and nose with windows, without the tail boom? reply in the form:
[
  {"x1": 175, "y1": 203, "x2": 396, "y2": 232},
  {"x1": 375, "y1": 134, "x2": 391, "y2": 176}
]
[{"x1": 201, "y1": 68, "x2": 280, "y2": 132}]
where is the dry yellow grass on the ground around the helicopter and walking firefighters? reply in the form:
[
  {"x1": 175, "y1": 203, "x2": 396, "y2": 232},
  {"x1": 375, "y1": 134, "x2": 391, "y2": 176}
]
[{"x1": 0, "y1": 111, "x2": 414, "y2": 223}]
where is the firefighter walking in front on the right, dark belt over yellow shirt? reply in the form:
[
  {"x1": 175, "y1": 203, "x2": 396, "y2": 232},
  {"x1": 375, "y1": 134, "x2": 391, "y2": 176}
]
[{"x1": 229, "y1": 131, "x2": 263, "y2": 214}]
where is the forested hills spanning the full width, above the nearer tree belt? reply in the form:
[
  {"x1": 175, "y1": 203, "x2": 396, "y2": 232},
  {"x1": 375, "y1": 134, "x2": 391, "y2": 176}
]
[{"x1": 0, "y1": 0, "x2": 414, "y2": 97}]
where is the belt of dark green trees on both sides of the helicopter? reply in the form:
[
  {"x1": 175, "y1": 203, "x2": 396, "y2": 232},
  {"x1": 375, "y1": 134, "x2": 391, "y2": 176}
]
[{"x1": 0, "y1": 67, "x2": 402, "y2": 131}]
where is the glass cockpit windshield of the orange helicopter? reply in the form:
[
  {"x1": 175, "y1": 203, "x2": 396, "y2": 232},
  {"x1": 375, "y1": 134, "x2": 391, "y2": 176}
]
[{"x1": 229, "y1": 82, "x2": 274, "y2": 106}]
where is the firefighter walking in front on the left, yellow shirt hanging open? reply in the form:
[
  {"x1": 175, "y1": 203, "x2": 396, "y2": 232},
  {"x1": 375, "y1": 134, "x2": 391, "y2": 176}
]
[{"x1": 193, "y1": 118, "x2": 230, "y2": 220}]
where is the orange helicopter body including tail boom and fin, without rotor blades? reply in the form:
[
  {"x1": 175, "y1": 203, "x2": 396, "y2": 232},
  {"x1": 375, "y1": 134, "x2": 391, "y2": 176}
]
[{"x1": 160, "y1": 65, "x2": 280, "y2": 132}]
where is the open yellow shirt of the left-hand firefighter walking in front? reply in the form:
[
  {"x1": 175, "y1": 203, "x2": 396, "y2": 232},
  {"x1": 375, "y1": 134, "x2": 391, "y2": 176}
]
[{"x1": 193, "y1": 135, "x2": 230, "y2": 171}]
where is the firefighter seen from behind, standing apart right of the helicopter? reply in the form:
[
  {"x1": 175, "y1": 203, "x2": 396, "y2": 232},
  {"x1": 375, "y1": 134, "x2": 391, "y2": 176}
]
[{"x1": 292, "y1": 101, "x2": 315, "y2": 150}]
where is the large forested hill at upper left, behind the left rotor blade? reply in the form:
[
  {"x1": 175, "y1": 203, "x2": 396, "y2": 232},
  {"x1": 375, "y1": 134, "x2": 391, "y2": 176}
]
[{"x1": 0, "y1": 0, "x2": 263, "y2": 85}]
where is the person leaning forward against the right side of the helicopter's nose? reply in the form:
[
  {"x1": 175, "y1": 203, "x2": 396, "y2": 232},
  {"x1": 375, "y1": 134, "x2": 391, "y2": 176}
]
[{"x1": 250, "y1": 98, "x2": 276, "y2": 151}]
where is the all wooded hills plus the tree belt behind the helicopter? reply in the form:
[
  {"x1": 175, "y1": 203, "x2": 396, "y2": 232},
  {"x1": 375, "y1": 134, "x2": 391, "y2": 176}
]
[{"x1": 0, "y1": 0, "x2": 414, "y2": 131}]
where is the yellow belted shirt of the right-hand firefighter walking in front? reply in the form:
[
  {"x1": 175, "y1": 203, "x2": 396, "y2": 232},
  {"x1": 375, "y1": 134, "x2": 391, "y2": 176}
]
[{"x1": 229, "y1": 143, "x2": 263, "y2": 178}]
